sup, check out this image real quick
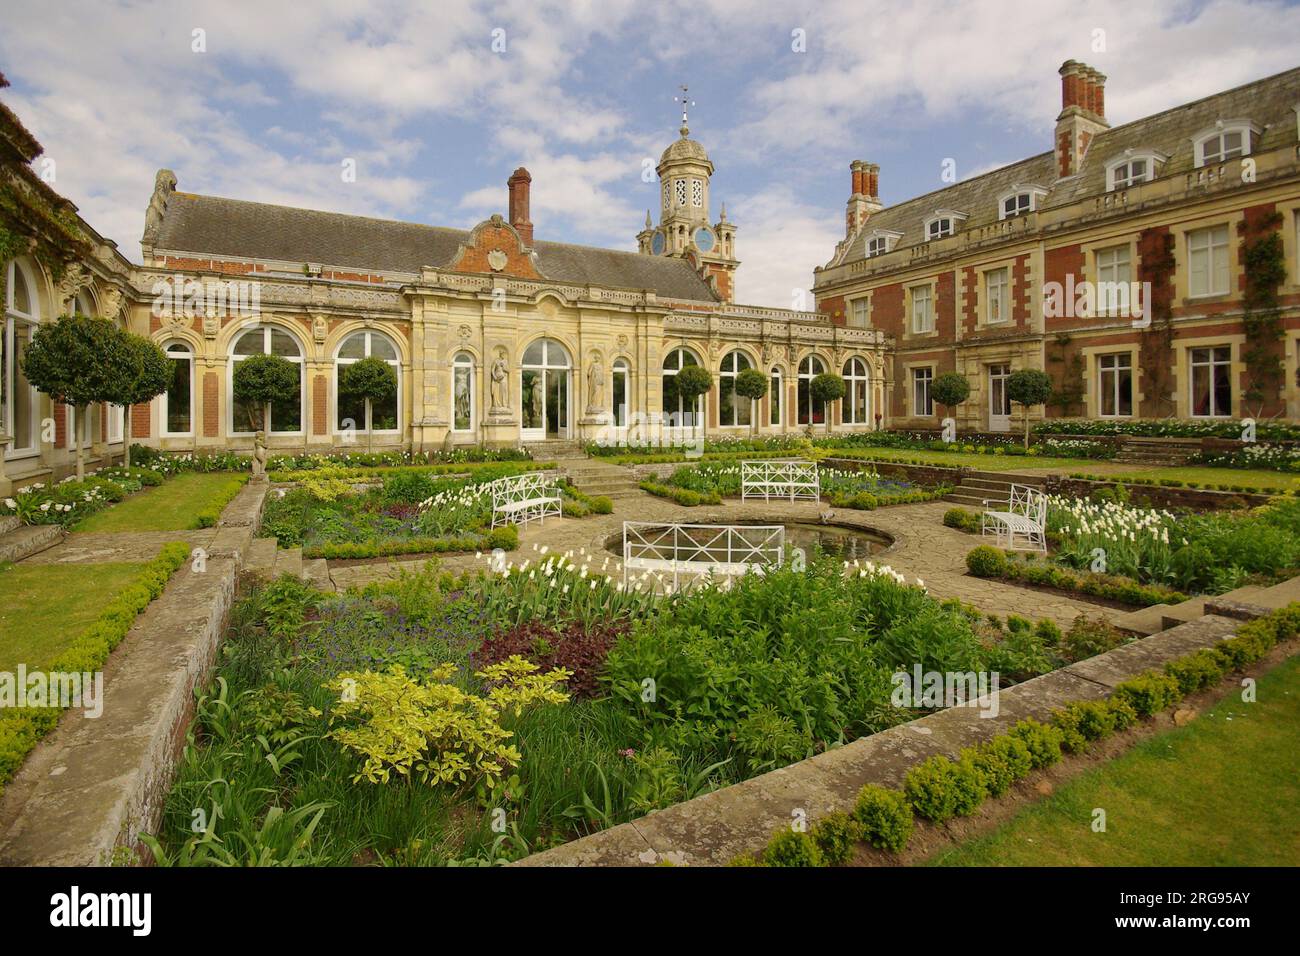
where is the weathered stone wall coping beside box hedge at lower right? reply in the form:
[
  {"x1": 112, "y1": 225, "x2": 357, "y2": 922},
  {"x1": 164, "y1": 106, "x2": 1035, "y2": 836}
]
[{"x1": 512, "y1": 609, "x2": 1242, "y2": 866}]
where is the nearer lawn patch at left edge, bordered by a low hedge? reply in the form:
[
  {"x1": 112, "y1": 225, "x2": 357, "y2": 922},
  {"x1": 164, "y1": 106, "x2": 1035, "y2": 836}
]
[{"x1": 0, "y1": 563, "x2": 143, "y2": 671}]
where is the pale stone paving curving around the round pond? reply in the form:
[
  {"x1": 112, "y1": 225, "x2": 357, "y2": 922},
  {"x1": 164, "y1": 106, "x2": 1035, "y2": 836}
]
[{"x1": 330, "y1": 493, "x2": 1118, "y2": 626}]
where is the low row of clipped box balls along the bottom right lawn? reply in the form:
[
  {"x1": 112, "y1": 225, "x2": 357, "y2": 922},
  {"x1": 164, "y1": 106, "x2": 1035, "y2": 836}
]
[{"x1": 732, "y1": 602, "x2": 1300, "y2": 866}]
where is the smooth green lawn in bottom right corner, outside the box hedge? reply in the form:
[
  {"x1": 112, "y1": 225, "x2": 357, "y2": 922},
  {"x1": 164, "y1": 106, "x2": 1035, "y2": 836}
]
[{"x1": 933, "y1": 658, "x2": 1300, "y2": 866}]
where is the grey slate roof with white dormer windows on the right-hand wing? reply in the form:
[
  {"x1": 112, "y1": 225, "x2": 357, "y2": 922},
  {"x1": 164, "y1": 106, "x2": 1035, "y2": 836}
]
[{"x1": 833, "y1": 68, "x2": 1300, "y2": 264}]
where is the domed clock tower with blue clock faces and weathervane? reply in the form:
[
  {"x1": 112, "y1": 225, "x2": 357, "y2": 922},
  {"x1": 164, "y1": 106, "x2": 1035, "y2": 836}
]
[{"x1": 637, "y1": 87, "x2": 740, "y2": 302}]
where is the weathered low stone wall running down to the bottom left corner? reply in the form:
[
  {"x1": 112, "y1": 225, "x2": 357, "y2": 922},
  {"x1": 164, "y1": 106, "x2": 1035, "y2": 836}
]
[{"x1": 0, "y1": 483, "x2": 267, "y2": 866}]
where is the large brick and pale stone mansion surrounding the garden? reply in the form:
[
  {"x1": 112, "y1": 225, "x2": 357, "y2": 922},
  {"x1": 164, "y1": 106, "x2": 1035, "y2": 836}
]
[{"x1": 0, "y1": 61, "x2": 1300, "y2": 490}]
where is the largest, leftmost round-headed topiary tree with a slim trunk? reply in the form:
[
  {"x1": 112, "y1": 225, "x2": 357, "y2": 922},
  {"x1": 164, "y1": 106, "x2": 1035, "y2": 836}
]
[{"x1": 21, "y1": 315, "x2": 131, "y2": 480}]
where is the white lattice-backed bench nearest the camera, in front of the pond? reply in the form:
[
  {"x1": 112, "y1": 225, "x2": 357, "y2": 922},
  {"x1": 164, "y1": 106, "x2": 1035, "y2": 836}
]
[{"x1": 623, "y1": 522, "x2": 785, "y2": 591}]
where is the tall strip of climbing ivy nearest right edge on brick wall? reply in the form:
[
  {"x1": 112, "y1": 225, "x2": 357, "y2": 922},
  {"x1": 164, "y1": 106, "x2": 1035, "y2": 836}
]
[{"x1": 1242, "y1": 211, "x2": 1287, "y2": 415}]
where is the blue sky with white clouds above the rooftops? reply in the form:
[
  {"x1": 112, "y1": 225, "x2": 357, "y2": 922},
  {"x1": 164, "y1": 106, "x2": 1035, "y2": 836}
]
[{"x1": 0, "y1": 0, "x2": 1300, "y2": 308}]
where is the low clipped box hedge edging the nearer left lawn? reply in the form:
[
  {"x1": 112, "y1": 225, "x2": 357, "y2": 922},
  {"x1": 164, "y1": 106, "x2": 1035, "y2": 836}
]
[{"x1": 0, "y1": 541, "x2": 190, "y2": 793}]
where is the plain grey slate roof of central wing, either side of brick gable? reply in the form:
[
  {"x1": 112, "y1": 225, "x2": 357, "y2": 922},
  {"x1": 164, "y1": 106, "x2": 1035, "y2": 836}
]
[{"x1": 153, "y1": 193, "x2": 718, "y2": 302}]
